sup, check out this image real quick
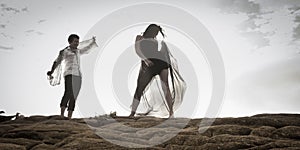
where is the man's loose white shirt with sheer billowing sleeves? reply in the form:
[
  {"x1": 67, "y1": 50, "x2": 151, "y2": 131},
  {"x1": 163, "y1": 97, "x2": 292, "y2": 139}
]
[{"x1": 49, "y1": 39, "x2": 98, "y2": 86}]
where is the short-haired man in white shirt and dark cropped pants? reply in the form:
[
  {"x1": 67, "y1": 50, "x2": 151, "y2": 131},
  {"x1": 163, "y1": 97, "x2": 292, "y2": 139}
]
[{"x1": 47, "y1": 34, "x2": 97, "y2": 119}]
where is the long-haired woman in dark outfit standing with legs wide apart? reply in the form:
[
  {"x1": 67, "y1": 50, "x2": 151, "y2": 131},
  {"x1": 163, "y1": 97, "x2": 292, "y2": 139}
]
[{"x1": 129, "y1": 24, "x2": 173, "y2": 118}]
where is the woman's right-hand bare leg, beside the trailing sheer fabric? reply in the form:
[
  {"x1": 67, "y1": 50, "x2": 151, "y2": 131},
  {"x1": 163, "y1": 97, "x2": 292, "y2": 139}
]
[{"x1": 159, "y1": 69, "x2": 173, "y2": 117}]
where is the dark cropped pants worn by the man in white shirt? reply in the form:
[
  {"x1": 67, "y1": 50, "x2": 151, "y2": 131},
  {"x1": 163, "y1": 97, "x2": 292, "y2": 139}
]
[{"x1": 60, "y1": 75, "x2": 81, "y2": 111}]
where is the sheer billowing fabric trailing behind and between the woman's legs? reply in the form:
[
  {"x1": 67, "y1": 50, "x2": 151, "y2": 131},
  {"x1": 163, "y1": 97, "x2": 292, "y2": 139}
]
[{"x1": 138, "y1": 41, "x2": 187, "y2": 117}]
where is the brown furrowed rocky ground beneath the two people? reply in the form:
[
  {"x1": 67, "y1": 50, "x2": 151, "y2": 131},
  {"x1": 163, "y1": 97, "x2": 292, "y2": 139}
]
[{"x1": 0, "y1": 114, "x2": 300, "y2": 150}]
